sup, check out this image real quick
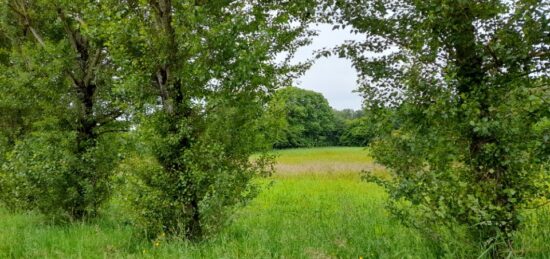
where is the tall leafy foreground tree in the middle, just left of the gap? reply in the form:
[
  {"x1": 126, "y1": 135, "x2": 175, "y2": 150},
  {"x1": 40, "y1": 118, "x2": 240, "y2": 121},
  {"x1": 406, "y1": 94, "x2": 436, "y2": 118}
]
[{"x1": 107, "y1": 0, "x2": 310, "y2": 240}]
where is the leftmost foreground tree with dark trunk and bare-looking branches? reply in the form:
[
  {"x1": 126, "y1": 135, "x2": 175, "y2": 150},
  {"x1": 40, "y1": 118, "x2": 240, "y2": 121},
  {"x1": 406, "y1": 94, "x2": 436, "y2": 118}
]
[{"x1": 0, "y1": 0, "x2": 125, "y2": 220}]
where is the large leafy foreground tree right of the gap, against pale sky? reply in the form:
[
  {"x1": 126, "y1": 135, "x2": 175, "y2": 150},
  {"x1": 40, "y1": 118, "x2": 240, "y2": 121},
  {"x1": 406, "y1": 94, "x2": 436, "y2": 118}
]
[{"x1": 324, "y1": 0, "x2": 550, "y2": 257}]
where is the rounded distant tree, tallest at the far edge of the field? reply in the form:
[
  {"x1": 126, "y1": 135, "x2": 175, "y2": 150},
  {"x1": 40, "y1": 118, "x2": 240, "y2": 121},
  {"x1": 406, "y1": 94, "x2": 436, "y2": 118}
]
[{"x1": 268, "y1": 87, "x2": 339, "y2": 148}]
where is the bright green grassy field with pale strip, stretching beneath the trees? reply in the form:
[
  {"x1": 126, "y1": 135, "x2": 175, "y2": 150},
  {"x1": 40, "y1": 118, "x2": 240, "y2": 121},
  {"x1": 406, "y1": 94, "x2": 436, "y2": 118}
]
[{"x1": 0, "y1": 148, "x2": 550, "y2": 258}]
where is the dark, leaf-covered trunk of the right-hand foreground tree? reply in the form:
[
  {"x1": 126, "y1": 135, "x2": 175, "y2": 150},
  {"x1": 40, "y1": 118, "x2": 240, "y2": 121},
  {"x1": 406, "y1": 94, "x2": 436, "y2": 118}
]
[{"x1": 451, "y1": 10, "x2": 517, "y2": 258}]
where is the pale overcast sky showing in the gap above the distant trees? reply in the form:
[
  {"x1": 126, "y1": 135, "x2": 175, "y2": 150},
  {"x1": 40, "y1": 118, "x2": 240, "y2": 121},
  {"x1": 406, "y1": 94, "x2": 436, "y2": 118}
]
[{"x1": 296, "y1": 25, "x2": 362, "y2": 110}]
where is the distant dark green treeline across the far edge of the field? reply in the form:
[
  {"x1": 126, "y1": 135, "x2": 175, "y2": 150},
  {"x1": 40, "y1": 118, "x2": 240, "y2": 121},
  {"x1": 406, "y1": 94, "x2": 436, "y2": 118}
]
[{"x1": 265, "y1": 87, "x2": 374, "y2": 148}]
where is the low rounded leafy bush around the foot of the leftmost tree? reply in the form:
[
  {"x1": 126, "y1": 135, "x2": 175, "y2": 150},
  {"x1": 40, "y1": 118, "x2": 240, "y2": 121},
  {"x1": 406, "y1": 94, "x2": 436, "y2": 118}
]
[{"x1": 0, "y1": 127, "x2": 118, "y2": 220}]
